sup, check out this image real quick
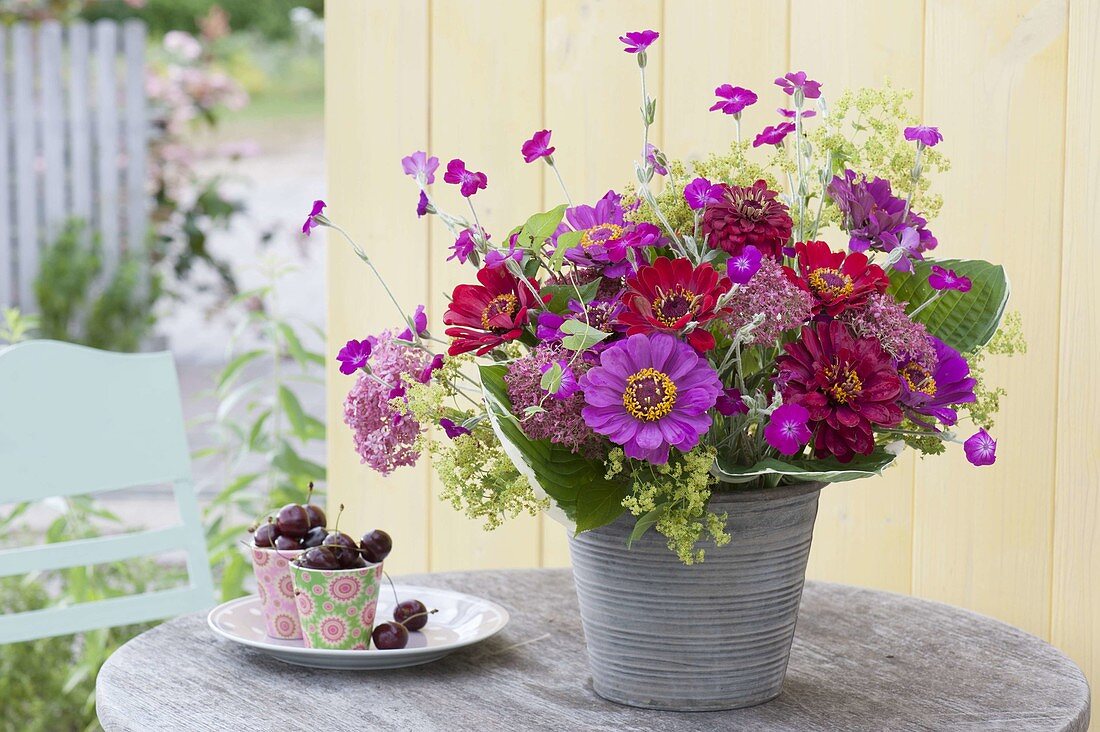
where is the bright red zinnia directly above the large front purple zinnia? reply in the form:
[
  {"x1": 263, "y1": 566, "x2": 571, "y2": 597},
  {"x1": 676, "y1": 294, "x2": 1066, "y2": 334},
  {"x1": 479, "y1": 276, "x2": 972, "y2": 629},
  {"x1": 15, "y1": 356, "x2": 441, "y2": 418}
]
[{"x1": 618, "y1": 256, "x2": 733, "y2": 352}]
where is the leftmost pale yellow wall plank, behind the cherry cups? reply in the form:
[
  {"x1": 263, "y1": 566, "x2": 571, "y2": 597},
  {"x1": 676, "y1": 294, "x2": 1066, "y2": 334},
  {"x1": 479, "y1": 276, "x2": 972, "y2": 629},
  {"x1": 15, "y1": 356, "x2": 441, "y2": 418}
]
[{"x1": 321, "y1": 0, "x2": 431, "y2": 572}]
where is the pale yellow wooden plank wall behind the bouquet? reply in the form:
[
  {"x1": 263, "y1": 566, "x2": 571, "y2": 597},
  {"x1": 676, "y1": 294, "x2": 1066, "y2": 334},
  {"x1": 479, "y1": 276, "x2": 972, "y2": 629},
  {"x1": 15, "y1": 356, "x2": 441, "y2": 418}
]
[{"x1": 326, "y1": 0, "x2": 1100, "y2": 685}]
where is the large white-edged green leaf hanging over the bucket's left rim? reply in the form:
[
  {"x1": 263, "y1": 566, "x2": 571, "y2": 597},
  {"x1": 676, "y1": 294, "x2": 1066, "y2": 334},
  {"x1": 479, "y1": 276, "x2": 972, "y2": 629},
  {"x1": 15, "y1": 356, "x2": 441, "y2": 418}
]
[{"x1": 479, "y1": 364, "x2": 626, "y2": 531}]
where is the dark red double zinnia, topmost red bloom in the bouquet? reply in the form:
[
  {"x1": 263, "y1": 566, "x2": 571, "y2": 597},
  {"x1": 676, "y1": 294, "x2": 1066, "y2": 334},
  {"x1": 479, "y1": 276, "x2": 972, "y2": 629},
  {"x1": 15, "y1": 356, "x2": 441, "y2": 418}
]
[{"x1": 703, "y1": 181, "x2": 792, "y2": 259}]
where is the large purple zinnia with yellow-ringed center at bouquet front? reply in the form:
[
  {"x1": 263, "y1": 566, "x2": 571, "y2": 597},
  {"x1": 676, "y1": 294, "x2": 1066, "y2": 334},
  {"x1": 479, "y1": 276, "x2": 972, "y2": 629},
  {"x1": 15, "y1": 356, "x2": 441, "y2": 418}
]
[{"x1": 581, "y1": 334, "x2": 722, "y2": 465}]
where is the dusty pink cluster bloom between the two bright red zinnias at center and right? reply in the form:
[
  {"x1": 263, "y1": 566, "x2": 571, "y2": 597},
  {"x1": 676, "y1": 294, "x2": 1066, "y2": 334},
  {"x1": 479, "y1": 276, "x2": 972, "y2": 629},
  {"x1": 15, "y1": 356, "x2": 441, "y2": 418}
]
[{"x1": 726, "y1": 256, "x2": 814, "y2": 346}]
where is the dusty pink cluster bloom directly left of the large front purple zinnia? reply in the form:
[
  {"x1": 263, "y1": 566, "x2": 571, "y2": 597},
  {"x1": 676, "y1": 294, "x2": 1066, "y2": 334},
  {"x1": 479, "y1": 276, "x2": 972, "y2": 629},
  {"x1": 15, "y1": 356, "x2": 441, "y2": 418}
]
[{"x1": 504, "y1": 345, "x2": 602, "y2": 458}]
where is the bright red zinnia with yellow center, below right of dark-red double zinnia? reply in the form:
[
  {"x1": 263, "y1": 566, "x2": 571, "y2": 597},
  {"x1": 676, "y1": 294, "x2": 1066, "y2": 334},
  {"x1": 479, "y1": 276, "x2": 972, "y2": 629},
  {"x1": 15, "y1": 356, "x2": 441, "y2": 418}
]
[{"x1": 794, "y1": 241, "x2": 890, "y2": 317}]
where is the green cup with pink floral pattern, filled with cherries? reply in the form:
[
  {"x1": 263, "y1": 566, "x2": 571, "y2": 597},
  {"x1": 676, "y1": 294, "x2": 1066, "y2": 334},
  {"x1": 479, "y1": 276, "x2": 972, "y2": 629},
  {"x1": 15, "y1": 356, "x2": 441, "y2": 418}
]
[{"x1": 290, "y1": 564, "x2": 382, "y2": 651}]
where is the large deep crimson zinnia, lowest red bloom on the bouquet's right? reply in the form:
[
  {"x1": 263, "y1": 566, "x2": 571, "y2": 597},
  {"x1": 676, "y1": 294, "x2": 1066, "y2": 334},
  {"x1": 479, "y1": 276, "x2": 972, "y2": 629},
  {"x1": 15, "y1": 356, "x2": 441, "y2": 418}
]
[{"x1": 777, "y1": 320, "x2": 902, "y2": 462}]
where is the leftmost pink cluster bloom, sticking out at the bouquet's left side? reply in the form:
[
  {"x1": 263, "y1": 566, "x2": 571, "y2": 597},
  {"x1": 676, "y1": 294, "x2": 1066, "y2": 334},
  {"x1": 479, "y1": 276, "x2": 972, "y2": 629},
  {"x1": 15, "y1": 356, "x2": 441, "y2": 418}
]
[{"x1": 344, "y1": 330, "x2": 429, "y2": 476}]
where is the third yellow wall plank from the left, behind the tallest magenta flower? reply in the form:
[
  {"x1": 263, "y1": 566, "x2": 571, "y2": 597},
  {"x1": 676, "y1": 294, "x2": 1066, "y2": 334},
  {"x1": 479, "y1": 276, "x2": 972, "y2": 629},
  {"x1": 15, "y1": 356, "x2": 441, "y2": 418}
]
[{"x1": 539, "y1": 0, "x2": 668, "y2": 567}]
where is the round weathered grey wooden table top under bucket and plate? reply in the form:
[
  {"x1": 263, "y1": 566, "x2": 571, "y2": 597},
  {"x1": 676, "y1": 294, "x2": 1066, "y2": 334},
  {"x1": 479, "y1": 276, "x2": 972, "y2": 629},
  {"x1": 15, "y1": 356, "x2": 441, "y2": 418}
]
[{"x1": 97, "y1": 569, "x2": 1089, "y2": 732}]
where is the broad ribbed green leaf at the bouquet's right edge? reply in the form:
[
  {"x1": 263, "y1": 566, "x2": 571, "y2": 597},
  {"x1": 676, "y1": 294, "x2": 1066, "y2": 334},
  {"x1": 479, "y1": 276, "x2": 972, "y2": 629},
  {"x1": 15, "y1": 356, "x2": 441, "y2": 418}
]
[{"x1": 888, "y1": 255, "x2": 1010, "y2": 352}]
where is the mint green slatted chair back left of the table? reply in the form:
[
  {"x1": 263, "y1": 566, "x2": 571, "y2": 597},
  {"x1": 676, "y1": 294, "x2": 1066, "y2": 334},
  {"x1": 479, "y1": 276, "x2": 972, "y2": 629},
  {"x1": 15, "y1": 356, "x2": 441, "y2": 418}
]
[{"x1": 0, "y1": 340, "x2": 213, "y2": 643}]
